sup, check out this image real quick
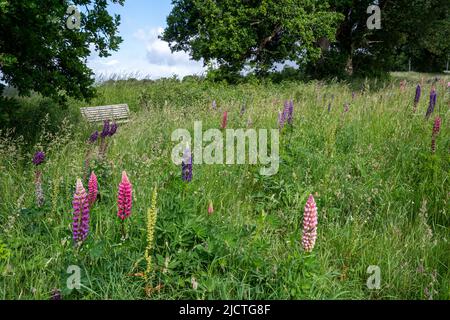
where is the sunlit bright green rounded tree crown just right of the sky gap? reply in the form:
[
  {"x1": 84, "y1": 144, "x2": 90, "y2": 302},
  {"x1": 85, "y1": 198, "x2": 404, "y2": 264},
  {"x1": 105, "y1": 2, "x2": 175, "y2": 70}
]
[{"x1": 162, "y1": 0, "x2": 343, "y2": 78}]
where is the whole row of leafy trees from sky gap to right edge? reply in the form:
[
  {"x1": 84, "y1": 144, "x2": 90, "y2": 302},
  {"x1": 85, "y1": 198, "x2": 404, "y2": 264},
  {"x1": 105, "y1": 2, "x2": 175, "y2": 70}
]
[{"x1": 162, "y1": 0, "x2": 450, "y2": 76}]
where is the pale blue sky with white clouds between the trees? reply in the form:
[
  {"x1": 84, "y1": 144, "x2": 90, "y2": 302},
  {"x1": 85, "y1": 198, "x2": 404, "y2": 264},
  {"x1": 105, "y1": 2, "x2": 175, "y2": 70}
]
[{"x1": 88, "y1": 0, "x2": 204, "y2": 79}]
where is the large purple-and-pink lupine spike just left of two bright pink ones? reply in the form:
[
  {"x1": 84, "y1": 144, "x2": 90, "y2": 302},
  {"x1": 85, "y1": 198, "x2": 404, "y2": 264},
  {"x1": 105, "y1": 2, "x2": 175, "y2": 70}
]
[{"x1": 72, "y1": 179, "x2": 89, "y2": 244}]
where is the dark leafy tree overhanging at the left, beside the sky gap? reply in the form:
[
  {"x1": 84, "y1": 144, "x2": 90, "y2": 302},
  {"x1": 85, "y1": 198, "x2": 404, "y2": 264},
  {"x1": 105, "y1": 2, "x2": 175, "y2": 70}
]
[{"x1": 0, "y1": 0, "x2": 124, "y2": 99}]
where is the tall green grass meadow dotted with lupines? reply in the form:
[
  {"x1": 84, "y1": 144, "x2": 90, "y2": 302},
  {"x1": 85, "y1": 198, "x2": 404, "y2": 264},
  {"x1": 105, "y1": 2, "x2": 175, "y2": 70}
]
[{"x1": 0, "y1": 74, "x2": 450, "y2": 300}]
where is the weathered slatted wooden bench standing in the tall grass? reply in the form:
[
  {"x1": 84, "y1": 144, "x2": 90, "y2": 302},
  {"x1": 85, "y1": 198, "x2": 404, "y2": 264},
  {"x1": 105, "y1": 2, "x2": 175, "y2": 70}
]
[{"x1": 80, "y1": 104, "x2": 130, "y2": 123}]
